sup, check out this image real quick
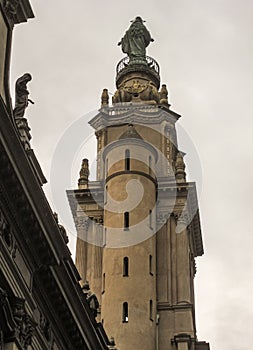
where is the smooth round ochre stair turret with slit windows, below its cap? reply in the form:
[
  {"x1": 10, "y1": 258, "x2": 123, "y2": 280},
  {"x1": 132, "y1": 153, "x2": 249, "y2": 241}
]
[{"x1": 101, "y1": 135, "x2": 156, "y2": 350}]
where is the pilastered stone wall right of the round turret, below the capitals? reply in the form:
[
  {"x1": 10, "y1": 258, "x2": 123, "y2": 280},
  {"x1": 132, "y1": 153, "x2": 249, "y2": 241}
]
[{"x1": 157, "y1": 217, "x2": 196, "y2": 350}]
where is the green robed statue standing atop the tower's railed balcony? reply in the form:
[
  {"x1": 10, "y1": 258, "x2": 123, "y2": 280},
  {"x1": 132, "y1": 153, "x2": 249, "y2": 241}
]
[{"x1": 118, "y1": 17, "x2": 154, "y2": 62}]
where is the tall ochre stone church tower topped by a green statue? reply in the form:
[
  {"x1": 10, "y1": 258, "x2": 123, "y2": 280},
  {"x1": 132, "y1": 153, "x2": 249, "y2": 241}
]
[{"x1": 68, "y1": 17, "x2": 209, "y2": 350}]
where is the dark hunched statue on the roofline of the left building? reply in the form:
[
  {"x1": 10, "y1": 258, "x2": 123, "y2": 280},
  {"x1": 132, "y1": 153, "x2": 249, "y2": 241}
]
[{"x1": 13, "y1": 73, "x2": 34, "y2": 118}]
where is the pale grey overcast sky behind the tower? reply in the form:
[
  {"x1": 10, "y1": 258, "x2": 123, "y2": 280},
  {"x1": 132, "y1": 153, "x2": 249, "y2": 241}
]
[{"x1": 11, "y1": 0, "x2": 253, "y2": 350}]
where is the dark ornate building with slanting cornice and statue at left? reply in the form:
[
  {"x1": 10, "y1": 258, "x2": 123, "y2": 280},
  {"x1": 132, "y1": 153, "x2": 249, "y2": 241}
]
[{"x1": 0, "y1": 0, "x2": 115, "y2": 350}]
